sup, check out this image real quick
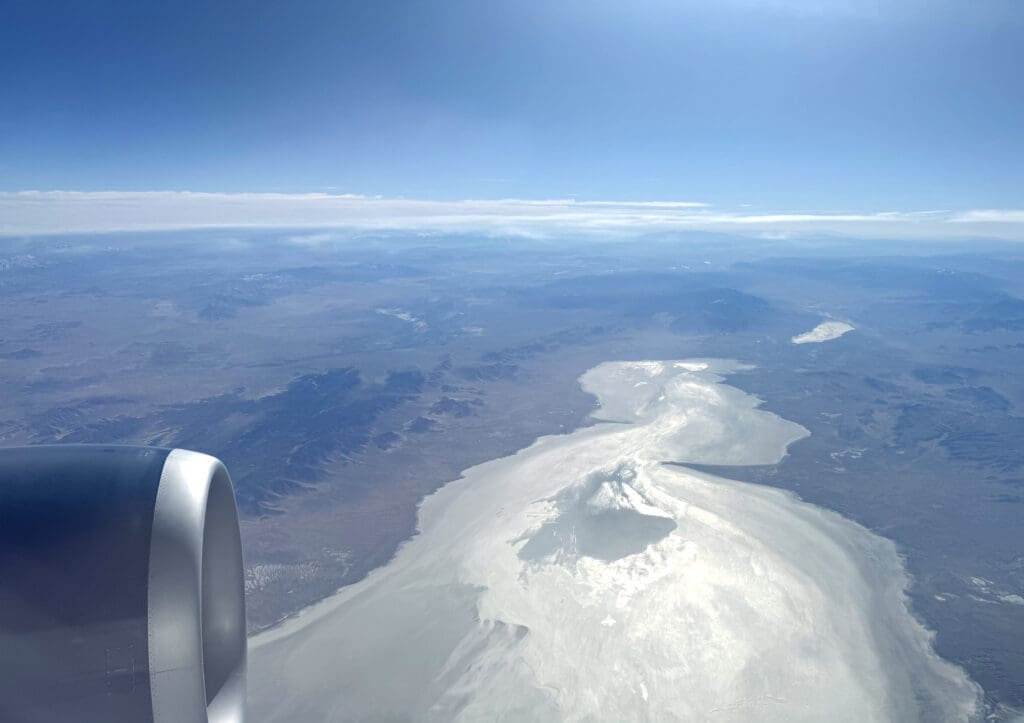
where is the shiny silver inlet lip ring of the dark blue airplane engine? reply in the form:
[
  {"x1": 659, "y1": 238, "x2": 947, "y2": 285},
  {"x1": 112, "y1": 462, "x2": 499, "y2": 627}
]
[{"x1": 147, "y1": 450, "x2": 246, "y2": 723}]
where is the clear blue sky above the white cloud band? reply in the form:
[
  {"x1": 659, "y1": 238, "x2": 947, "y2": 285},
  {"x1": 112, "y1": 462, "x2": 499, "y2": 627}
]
[{"x1": 0, "y1": 0, "x2": 1024, "y2": 213}]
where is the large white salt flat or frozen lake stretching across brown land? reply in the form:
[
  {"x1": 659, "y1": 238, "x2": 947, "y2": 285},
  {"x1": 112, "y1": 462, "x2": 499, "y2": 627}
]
[{"x1": 250, "y1": 360, "x2": 980, "y2": 722}]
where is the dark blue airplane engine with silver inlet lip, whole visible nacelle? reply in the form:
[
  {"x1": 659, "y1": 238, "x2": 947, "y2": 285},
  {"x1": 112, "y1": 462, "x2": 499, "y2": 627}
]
[{"x1": 0, "y1": 445, "x2": 246, "y2": 723}]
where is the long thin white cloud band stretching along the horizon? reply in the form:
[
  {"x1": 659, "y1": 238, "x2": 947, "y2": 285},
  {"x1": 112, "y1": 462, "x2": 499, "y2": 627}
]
[{"x1": 0, "y1": 190, "x2": 1024, "y2": 241}]
